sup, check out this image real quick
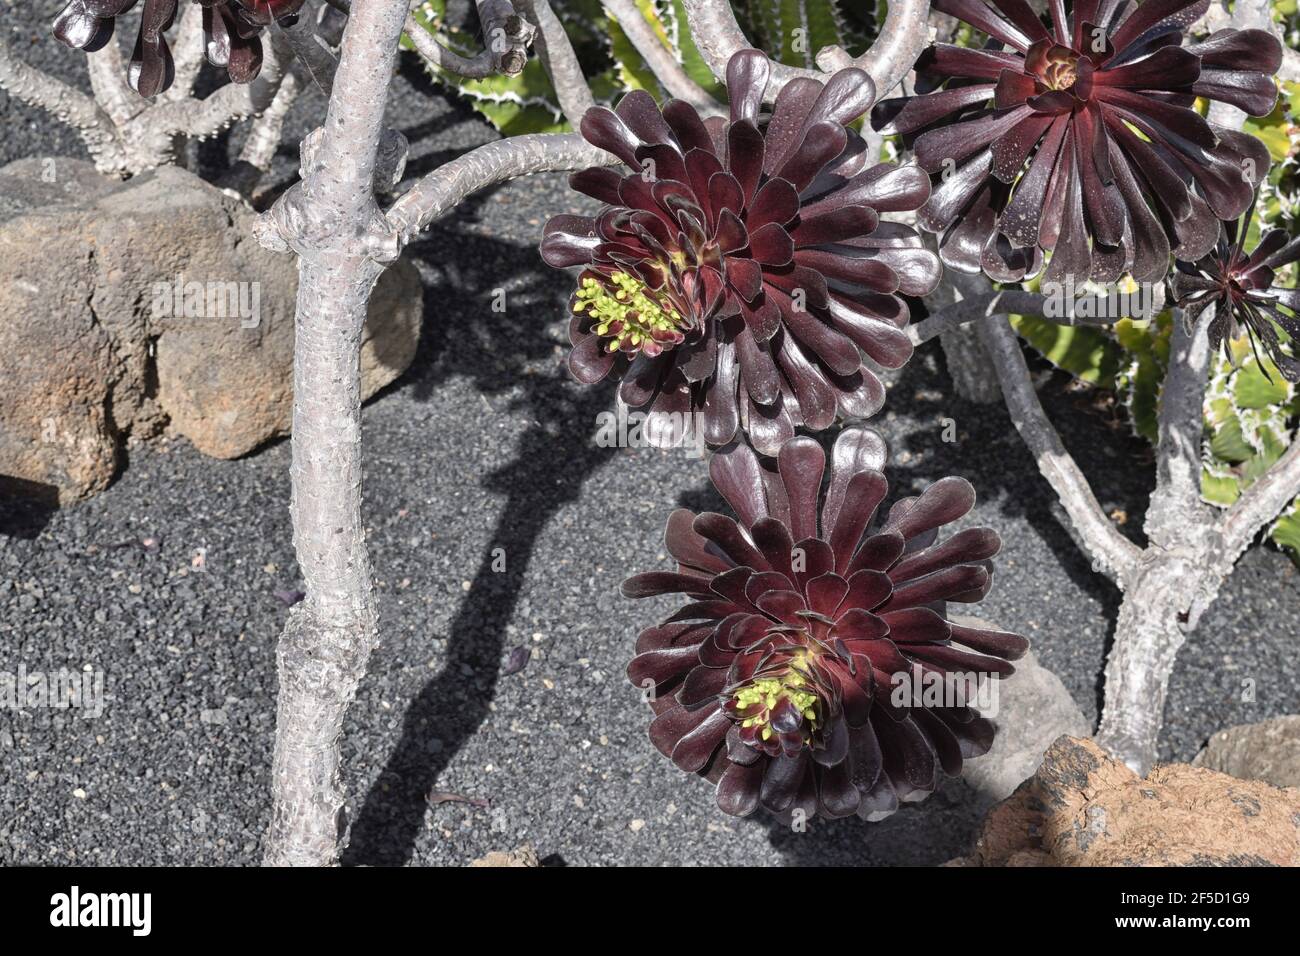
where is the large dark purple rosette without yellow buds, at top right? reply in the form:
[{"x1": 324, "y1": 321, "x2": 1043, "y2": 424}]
[{"x1": 872, "y1": 0, "x2": 1282, "y2": 282}]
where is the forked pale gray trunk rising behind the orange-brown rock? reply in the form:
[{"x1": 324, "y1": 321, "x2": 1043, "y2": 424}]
[{"x1": 956, "y1": 239, "x2": 1300, "y2": 773}]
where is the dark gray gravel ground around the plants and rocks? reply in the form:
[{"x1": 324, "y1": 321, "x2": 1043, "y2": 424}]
[{"x1": 0, "y1": 0, "x2": 1300, "y2": 865}]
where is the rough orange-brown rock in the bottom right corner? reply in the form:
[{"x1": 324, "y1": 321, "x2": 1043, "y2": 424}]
[{"x1": 953, "y1": 736, "x2": 1300, "y2": 866}]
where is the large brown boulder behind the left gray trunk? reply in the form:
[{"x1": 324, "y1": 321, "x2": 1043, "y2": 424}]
[{"x1": 0, "y1": 159, "x2": 421, "y2": 503}]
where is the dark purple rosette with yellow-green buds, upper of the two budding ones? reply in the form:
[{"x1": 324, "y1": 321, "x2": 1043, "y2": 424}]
[{"x1": 542, "y1": 49, "x2": 940, "y2": 454}]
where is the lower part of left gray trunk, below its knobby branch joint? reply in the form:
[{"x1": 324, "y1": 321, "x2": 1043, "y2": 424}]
[{"x1": 267, "y1": 259, "x2": 380, "y2": 866}]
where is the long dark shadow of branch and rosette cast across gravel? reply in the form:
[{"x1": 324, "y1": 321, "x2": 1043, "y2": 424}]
[{"x1": 342, "y1": 222, "x2": 616, "y2": 866}]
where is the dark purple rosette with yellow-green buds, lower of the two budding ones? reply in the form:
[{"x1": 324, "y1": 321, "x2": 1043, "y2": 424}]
[{"x1": 623, "y1": 427, "x2": 1028, "y2": 819}]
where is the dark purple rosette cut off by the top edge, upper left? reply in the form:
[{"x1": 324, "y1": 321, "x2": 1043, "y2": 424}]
[{"x1": 55, "y1": 0, "x2": 303, "y2": 96}]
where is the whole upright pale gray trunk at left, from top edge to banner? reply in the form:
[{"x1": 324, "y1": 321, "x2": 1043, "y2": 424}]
[{"x1": 265, "y1": 0, "x2": 407, "y2": 866}]
